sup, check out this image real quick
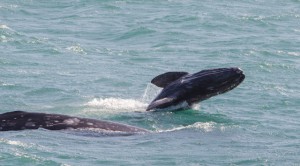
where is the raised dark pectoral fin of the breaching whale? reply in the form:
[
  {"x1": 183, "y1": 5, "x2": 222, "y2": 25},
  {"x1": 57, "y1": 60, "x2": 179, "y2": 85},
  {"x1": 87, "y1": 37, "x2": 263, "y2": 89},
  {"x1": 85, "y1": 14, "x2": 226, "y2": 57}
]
[{"x1": 151, "y1": 72, "x2": 188, "y2": 88}]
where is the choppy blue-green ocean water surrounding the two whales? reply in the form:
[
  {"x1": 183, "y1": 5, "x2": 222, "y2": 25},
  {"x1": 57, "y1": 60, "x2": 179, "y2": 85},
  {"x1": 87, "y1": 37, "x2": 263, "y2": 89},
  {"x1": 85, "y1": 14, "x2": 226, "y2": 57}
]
[{"x1": 0, "y1": 0, "x2": 300, "y2": 166}]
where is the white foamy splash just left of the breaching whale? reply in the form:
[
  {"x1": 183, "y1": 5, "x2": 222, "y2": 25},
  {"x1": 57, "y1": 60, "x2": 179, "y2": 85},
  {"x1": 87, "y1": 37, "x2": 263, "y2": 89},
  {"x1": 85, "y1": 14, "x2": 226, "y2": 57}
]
[{"x1": 85, "y1": 98, "x2": 147, "y2": 112}]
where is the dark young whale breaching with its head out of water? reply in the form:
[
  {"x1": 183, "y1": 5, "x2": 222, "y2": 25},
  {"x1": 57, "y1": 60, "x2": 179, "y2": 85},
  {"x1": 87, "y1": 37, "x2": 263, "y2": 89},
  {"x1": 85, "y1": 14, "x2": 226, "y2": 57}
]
[{"x1": 146, "y1": 68, "x2": 245, "y2": 111}]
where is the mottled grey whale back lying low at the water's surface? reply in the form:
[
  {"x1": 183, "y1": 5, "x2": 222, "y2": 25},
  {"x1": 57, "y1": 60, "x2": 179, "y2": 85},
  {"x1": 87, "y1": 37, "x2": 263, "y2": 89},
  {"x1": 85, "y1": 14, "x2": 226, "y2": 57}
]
[{"x1": 0, "y1": 111, "x2": 149, "y2": 133}]
